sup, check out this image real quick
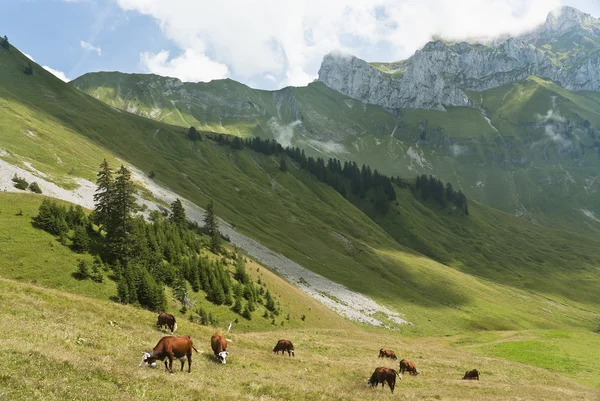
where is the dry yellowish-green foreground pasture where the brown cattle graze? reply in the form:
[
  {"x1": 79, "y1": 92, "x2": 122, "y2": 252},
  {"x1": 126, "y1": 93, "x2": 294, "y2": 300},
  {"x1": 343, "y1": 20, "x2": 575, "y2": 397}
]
[{"x1": 0, "y1": 278, "x2": 599, "y2": 400}]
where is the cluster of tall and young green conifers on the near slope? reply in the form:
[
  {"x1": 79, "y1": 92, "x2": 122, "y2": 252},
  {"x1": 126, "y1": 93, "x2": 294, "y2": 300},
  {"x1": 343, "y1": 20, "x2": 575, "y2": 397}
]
[{"x1": 33, "y1": 160, "x2": 279, "y2": 320}]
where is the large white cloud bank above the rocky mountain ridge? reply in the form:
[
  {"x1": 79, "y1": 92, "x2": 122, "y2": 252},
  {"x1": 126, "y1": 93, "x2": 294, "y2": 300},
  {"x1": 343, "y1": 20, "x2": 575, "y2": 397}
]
[{"x1": 117, "y1": 0, "x2": 600, "y2": 86}]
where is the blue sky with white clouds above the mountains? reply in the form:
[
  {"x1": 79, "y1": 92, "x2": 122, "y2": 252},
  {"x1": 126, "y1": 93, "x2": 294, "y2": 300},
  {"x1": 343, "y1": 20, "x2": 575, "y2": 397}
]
[{"x1": 0, "y1": 0, "x2": 600, "y2": 89}]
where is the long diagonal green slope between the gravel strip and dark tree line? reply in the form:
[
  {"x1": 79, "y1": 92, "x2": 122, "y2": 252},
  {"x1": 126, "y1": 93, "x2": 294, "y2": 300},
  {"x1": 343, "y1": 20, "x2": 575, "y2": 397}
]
[{"x1": 0, "y1": 42, "x2": 598, "y2": 335}]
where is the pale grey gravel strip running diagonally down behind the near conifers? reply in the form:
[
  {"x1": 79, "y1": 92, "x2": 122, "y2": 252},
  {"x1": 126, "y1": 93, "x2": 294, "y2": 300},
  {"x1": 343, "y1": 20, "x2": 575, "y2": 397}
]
[{"x1": 0, "y1": 159, "x2": 412, "y2": 328}]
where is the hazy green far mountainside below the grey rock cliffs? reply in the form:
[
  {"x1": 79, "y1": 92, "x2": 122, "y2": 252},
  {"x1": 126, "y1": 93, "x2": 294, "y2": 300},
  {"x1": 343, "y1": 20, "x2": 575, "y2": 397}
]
[{"x1": 72, "y1": 69, "x2": 600, "y2": 233}]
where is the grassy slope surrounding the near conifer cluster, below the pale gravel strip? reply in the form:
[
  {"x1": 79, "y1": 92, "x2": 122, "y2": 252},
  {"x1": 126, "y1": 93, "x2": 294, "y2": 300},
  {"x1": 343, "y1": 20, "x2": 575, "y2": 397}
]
[{"x1": 0, "y1": 193, "x2": 351, "y2": 331}]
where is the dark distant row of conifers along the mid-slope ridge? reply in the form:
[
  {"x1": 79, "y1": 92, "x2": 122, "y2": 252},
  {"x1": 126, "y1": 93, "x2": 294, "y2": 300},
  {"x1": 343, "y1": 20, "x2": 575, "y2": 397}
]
[{"x1": 209, "y1": 134, "x2": 469, "y2": 215}]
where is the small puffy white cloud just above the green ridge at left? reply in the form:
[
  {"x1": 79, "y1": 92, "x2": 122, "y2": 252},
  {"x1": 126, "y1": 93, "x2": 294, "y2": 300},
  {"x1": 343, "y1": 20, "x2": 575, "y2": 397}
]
[{"x1": 140, "y1": 49, "x2": 229, "y2": 82}]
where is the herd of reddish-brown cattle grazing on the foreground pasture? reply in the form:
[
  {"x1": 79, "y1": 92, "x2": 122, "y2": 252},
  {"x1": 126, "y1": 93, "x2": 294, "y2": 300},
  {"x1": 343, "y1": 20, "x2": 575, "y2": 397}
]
[{"x1": 139, "y1": 312, "x2": 479, "y2": 393}]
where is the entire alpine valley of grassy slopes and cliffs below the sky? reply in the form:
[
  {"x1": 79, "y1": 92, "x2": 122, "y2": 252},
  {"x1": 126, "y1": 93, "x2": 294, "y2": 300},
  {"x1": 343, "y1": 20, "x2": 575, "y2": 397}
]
[{"x1": 0, "y1": 4, "x2": 600, "y2": 400}]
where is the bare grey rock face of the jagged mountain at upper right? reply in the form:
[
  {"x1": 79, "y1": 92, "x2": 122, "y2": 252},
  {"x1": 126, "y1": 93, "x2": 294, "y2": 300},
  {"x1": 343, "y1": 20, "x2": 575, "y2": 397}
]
[{"x1": 319, "y1": 7, "x2": 600, "y2": 110}]
